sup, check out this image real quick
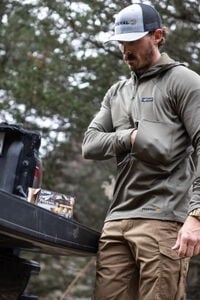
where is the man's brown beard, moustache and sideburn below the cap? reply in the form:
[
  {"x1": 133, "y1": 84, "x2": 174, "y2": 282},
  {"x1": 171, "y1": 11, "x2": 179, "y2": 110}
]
[{"x1": 123, "y1": 42, "x2": 154, "y2": 75}]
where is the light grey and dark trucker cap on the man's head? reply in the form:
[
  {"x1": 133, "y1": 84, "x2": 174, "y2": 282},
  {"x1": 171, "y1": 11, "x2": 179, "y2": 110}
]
[{"x1": 105, "y1": 3, "x2": 162, "y2": 43}]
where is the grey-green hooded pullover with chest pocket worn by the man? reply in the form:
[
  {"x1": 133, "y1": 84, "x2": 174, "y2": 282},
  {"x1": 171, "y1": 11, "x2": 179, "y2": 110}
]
[{"x1": 82, "y1": 53, "x2": 200, "y2": 222}]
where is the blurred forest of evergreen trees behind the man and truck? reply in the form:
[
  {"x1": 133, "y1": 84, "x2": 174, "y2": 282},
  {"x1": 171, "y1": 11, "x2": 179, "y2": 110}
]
[{"x1": 0, "y1": 0, "x2": 200, "y2": 300}]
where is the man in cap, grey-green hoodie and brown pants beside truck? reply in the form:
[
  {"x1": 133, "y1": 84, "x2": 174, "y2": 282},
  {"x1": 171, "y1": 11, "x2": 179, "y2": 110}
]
[{"x1": 83, "y1": 4, "x2": 200, "y2": 300}]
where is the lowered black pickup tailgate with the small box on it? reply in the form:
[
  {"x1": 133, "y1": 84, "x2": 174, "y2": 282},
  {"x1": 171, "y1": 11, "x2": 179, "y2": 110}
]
[{"x1": 0, "y1": 190, "x2": 100, "y2": 256}]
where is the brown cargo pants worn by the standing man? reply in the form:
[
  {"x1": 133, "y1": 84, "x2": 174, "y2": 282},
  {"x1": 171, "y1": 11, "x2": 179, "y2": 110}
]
[{"x1": 93, "y1": 219, "x2": 189, "y2": 300}]
